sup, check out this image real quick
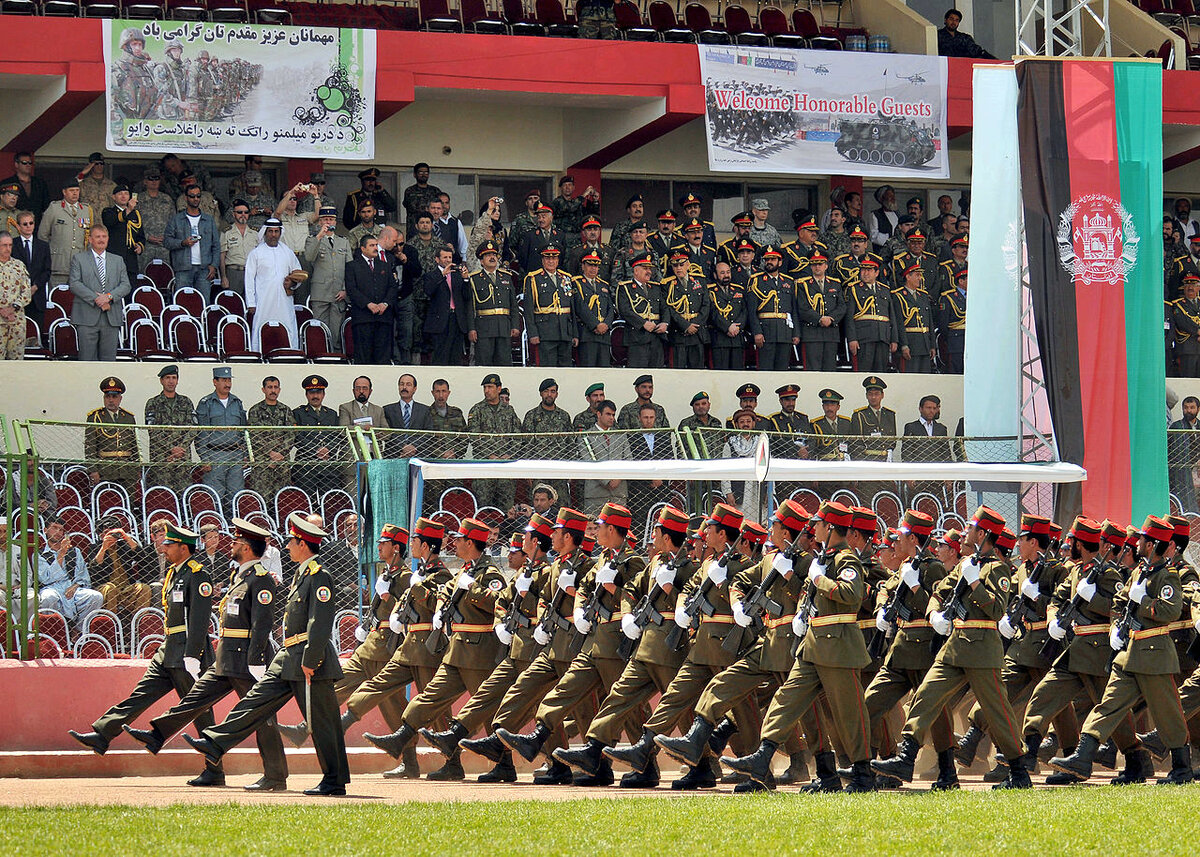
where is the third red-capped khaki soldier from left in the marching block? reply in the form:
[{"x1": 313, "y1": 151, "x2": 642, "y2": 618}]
[{"x1": 364, "y1": 517, "x2": 506, "y2": 780}]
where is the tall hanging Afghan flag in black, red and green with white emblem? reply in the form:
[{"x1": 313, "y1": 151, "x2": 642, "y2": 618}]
[{"x1": 1017, "y1": 58, "x2": 1168, "y2": 522}]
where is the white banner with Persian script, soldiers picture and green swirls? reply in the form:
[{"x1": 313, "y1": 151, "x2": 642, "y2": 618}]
[{"x1": 103, "y1": 20, "x2": 376, "y2": 160}]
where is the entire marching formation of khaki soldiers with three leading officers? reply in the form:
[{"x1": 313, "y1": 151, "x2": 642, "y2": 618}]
[{"x1": 65, "y1": 499, "x2": 1200, "y2": 795}]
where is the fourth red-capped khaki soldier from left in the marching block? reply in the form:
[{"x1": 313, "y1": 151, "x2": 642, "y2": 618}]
[{"x1": 420, "y1": 513, "x2": 554, "y2": 783}]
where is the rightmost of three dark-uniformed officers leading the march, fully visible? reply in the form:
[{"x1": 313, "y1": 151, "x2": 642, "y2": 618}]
[{"x1": 184, "y1": 513, "x2": 350, "y2": 796}]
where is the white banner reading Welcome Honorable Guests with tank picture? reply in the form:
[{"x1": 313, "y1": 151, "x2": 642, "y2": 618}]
[{"x1": 697, "y1": 44, "x2": 950, "y2": 179}]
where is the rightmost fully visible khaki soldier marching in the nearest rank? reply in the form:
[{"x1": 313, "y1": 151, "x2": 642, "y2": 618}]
[{"x1": 1050, "y1": 515, "x2": 1192, "y2": 785}]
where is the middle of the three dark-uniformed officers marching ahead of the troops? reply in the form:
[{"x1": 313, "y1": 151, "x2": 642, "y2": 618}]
[{"x1": 121, "y1": 517, "x2": 288, "y2": 791}]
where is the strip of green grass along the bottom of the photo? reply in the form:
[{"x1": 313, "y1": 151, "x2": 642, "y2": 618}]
[{"x1": 0, "y1": 780, "x2": 1200, "y2": 857}]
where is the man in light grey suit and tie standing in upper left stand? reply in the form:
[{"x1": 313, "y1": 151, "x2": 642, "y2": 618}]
[{"x1": 67, "y1": 226, "x2": 131, "y2": 361}]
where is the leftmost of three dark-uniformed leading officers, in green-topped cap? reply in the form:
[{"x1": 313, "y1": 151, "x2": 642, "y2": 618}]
[{"x1": 71, "y1": 523, "x2": 224, "y2": 786}]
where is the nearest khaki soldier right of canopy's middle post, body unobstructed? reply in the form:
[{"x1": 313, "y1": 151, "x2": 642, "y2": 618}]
[{"x1": 721, "y1": 502, "x2": 875, "y2": 792}]
